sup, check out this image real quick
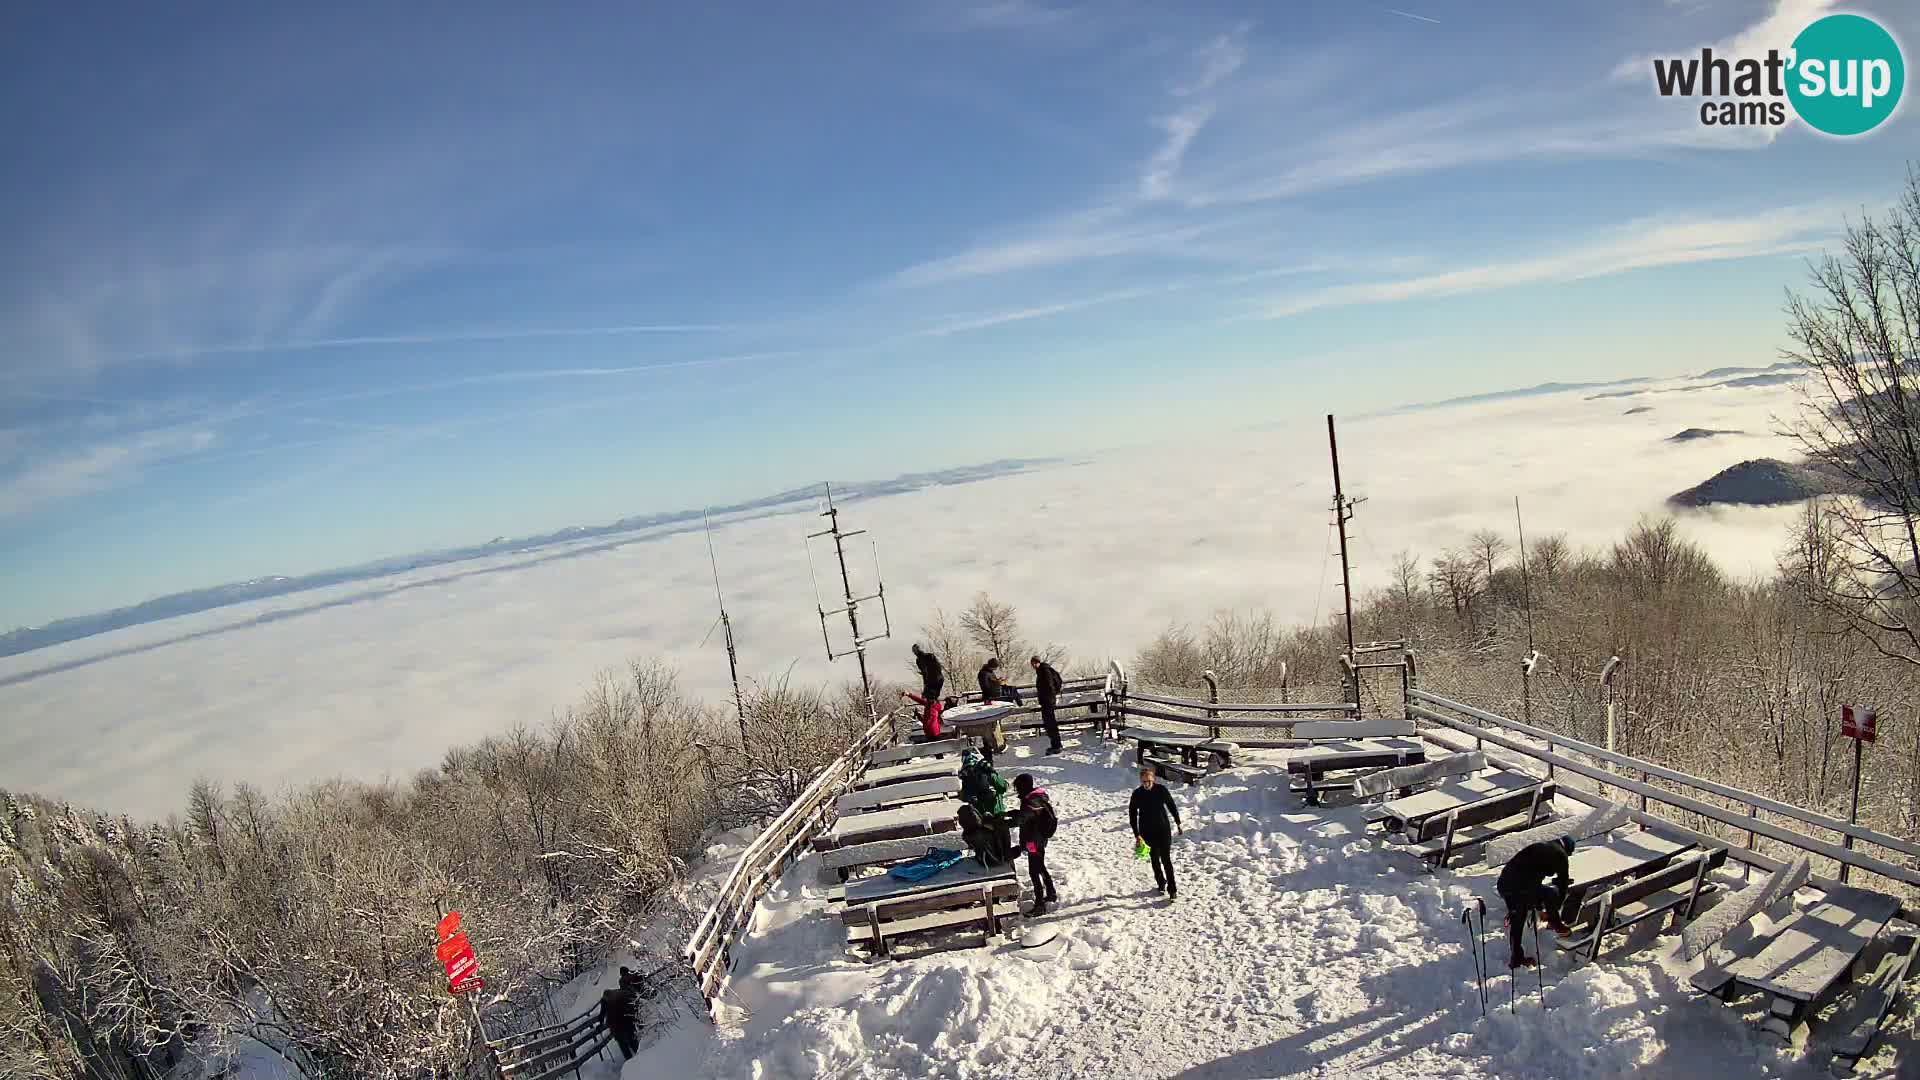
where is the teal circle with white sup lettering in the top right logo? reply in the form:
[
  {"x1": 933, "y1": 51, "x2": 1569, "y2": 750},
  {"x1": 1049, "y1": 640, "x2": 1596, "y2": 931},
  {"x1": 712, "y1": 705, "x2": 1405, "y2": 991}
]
[{"x1": 1788, "y1": 15, "x2": 1907, "y2": 136}]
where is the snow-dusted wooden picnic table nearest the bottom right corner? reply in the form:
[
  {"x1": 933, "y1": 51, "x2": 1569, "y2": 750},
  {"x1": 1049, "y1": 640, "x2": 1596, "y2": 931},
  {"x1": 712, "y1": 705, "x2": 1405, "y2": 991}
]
[{"x1": 1692, "y1": 886, "x2": 1901, "y2": 1042}]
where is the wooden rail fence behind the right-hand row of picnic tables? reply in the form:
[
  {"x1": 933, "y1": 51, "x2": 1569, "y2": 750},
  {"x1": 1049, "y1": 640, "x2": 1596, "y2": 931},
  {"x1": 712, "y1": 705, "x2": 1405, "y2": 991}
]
[{"x1": 1407, "y1": 690, "x2": 1920, "y2": 903}]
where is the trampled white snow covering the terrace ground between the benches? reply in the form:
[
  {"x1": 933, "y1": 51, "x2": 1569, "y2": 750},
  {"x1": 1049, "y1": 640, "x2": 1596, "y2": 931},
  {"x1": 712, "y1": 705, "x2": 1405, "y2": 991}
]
[{"x1": 622, "y1": 736, "x2": 1920, "y2": 1080}]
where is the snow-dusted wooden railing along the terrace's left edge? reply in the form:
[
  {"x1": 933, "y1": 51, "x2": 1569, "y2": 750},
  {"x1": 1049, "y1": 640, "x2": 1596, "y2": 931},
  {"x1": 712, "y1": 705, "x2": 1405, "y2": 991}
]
[{"x1": 682, "y1": 713, "x2": 895, "y2": 1017}]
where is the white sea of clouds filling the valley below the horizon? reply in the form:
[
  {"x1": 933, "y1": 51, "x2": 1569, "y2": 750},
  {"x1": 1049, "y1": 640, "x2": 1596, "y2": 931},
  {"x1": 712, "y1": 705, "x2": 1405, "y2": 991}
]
[{"x1": 0, "y1": 367, "x2": 1793, "y2": 815}]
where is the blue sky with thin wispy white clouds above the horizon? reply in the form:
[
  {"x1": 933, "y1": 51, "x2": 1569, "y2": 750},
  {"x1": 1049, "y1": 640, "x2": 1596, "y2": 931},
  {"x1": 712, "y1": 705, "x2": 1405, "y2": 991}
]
[{"x1": 0, "y1": 0, "x2": 1920, "y2": 626}]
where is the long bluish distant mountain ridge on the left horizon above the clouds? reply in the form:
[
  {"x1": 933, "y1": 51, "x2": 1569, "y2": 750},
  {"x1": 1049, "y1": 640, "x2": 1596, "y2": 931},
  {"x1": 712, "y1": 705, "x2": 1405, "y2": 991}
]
[{"x1": 0, "y1": 457, "x2": 1064, "y2": 657}]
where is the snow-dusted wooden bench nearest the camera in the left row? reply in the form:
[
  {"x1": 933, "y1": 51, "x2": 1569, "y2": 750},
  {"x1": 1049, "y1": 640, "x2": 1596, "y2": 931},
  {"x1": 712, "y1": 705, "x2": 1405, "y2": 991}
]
[{"x1": 839, "y1": 859, "x2": 1020, "y2": 957}]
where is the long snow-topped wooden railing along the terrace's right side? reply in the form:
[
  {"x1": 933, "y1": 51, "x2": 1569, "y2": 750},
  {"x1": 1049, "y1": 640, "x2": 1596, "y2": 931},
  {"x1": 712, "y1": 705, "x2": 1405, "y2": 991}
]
[{"x1": 1407, "y1": 690, "x2": 1920, "y2": 886}]
